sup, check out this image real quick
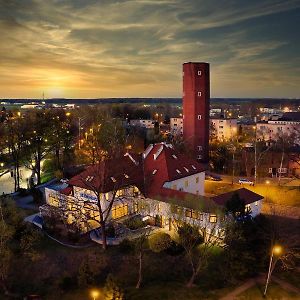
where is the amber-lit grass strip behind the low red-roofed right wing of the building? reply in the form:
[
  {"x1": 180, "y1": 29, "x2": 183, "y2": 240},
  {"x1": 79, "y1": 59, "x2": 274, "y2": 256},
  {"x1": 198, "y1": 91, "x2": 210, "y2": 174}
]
[{"x1": 205, "y1": 181, "x2": 300, "y2": 207}]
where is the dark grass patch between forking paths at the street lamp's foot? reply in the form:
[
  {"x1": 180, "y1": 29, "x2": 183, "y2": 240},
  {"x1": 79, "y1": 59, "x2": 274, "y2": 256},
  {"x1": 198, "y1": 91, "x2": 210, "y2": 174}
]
[{"x1": 236, "y1": 283, "x2": 299, "y2": 300}]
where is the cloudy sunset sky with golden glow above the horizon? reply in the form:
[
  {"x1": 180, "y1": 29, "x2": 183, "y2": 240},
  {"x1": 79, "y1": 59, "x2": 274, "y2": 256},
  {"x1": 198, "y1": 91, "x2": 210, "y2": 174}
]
[{"x1": 0, "y1": 0, "x2": 300, "y2": 98}]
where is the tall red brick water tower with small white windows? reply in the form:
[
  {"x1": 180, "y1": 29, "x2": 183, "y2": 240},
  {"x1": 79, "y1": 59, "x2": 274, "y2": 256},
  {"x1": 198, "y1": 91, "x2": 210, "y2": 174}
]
[{"x1": 183, "y1": 62, "x2": 210, "y2": 163}]
